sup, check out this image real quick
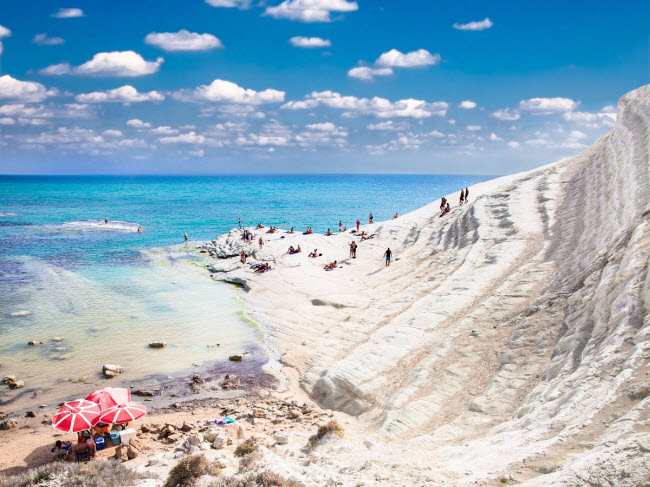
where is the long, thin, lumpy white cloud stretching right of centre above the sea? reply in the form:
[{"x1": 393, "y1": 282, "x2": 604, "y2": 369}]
[{"x1": 282, "y1": 91, "x2": 448, "y2": 118}]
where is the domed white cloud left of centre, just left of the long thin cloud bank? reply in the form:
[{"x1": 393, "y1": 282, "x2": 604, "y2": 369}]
[{"x1": 174, "y1": 79, "x2": 284, "y2": 105}]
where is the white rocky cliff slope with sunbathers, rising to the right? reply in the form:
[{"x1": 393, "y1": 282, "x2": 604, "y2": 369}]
[{"x1": 209, "y1": 85, "x2": 650, "y2": 486}]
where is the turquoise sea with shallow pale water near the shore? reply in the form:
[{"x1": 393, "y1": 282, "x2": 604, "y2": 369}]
[{"x1": 0, "y1": 175, "x2": 490, "y2": 413}]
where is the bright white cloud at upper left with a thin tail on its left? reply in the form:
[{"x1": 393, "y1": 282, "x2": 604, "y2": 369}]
[{"x1": 40, "y1": 51, "x2": 163, "y2": 78}]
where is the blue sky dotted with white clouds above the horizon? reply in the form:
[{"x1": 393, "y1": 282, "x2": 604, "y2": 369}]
[{"x1": 0, "y1": 0, "x2": 650, "y2": 175}]
